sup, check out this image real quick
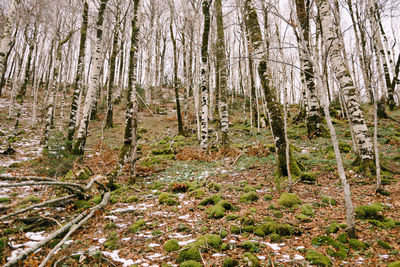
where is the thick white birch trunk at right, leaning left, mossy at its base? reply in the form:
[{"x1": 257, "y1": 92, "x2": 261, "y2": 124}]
[{"x1": 317, "y1": 0, "x2": 375, "y2": 174}]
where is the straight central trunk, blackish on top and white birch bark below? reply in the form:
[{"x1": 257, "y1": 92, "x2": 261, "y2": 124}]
[{"x1": 200, "y1": 0, "x2": 211, "y2": 149}]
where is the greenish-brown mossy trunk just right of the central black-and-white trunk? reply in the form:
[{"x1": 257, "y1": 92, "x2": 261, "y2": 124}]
[{"x1": 215, "y1": 0, "x2": 229, "y2": 146}]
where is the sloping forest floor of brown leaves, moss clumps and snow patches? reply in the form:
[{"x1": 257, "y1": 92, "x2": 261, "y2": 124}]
[{"x1": 0, "y1": 87, "x2": 400, "y2": 266}]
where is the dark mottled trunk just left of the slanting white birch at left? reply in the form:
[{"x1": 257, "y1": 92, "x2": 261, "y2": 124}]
[{"x1": 67, "y1": 0, "x2": 89, "y2": 150}]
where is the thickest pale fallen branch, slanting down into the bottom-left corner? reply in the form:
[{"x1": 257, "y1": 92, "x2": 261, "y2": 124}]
[{"x1": 3, "y1": 192, "x2": 110, "y2": 267}]
